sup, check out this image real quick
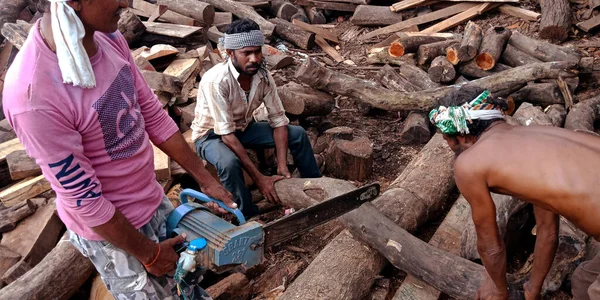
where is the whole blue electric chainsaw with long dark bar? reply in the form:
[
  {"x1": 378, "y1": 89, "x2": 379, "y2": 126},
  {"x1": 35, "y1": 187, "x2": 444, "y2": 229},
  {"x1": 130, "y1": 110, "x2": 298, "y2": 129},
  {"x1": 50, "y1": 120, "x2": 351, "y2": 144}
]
[{"x1": 167, "y1": 183, "x2": 380, "y2": 273}]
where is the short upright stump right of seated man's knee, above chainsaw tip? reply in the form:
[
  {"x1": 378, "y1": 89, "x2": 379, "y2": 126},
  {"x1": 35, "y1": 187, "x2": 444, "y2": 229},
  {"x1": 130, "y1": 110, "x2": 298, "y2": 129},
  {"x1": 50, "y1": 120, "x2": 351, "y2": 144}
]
[{"x1": 325, "y1": 137, "x2": 373, "y2": 181}]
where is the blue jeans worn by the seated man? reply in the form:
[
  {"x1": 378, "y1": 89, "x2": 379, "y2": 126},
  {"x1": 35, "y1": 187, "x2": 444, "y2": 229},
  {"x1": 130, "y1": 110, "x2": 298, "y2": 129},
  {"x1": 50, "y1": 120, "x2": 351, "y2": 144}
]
[{"x1": 195, "y1": 122, "x2": 321, "y2": 218}]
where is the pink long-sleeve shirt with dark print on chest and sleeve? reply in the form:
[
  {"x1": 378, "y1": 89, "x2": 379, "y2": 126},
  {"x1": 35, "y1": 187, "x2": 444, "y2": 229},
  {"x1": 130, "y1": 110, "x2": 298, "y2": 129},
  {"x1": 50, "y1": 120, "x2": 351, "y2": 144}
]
[{"x1": 2, "y1": 24, "x2": 178, "y2": 240}]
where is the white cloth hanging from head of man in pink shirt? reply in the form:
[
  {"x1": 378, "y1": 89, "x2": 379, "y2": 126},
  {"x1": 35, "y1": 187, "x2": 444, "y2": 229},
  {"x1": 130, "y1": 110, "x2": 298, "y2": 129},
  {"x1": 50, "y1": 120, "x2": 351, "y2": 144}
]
[{"x1": 48, "y1": 0, "x2": 96, "y2": 88}]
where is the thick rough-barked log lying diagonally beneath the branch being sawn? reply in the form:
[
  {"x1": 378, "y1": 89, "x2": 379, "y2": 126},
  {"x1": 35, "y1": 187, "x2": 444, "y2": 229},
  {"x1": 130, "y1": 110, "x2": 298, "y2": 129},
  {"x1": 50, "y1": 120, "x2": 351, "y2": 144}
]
[{"x1": 277, "y1": 135, "x2": 455, "y2": 299}]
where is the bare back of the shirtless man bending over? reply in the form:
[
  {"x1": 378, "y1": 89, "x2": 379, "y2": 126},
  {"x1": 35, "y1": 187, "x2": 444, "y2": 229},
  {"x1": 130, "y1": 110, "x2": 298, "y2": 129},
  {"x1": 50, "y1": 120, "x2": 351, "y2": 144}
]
[{"x1": 455, "y1": 122, "x2": 600, "y2": 240}]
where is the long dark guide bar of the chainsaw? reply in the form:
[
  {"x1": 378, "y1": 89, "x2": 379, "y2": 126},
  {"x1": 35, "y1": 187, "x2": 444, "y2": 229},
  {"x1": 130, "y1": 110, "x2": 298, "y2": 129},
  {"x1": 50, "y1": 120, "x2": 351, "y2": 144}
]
[{"x1": 263, "y1": 183, "x2": 380, "y2": 247}]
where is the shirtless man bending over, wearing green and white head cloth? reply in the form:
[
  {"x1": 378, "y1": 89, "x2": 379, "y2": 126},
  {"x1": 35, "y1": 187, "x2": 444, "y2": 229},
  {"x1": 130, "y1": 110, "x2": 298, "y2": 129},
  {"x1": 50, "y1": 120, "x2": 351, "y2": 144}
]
[{"x1": 429, "y1": 87, "x2": 600, "y2": 299}]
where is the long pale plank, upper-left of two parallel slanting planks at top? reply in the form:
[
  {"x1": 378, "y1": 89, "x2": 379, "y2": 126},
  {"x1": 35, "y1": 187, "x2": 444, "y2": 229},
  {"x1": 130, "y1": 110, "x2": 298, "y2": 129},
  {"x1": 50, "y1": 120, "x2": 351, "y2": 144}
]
[{"x1": 358, "y1": 3, "x2": 478, "y2": 41}]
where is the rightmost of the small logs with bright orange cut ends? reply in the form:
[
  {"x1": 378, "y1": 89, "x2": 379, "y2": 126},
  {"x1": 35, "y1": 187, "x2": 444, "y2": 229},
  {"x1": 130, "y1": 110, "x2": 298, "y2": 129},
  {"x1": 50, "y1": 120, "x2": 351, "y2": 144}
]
[{"x1": 475, "y1": 27, "x2": 512, "y2": 71}]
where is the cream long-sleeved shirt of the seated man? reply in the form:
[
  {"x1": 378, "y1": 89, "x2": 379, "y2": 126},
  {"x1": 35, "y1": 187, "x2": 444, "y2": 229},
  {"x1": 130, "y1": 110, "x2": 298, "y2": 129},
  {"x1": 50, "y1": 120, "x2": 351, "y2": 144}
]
[{"x1": 192, "y1": 59, "x2": 289, "y2": 141}]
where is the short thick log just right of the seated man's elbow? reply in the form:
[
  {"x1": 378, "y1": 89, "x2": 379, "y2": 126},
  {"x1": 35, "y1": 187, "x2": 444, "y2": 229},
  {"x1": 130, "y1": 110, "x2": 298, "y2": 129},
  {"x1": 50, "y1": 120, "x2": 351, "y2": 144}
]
[{"x1": 277, "y1": 82, "x2": 335, "y2": 117}]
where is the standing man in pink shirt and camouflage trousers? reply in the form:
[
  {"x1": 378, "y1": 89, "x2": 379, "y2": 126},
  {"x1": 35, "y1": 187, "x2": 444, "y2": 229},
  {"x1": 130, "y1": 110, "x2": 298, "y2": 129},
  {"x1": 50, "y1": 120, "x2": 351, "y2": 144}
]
[{"x1": 3, "y1": 0, "x2": 236, "y2": 299}]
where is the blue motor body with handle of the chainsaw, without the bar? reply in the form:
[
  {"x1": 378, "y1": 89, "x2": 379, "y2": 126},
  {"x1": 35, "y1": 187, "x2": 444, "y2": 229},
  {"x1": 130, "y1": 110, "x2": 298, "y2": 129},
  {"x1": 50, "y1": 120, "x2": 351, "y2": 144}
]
[{"x1": 167, "y1": 189, "x2": 263, "y2": 269}]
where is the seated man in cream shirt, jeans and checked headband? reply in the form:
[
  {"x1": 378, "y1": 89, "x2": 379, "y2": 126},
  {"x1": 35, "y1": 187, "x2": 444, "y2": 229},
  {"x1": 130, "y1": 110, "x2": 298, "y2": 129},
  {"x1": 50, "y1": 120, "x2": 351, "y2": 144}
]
[{"x1": 192, "y1": 19, "x2": 320, "y2": 217}]
